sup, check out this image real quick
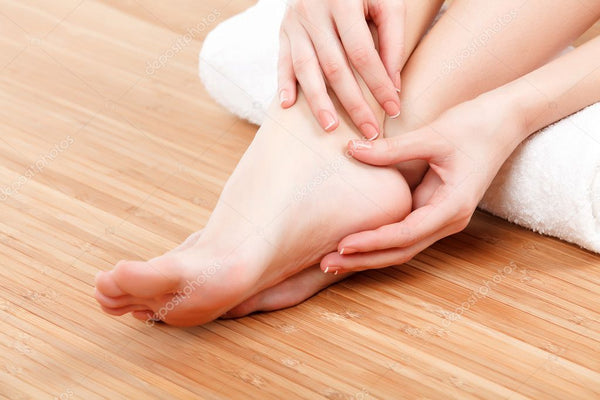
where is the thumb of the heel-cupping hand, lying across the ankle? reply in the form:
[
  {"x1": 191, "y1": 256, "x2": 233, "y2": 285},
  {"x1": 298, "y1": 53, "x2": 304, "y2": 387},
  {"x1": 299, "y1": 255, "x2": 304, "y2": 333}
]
[{"x1": 348, "y1": 127, "x2": 450, "y2": 166}]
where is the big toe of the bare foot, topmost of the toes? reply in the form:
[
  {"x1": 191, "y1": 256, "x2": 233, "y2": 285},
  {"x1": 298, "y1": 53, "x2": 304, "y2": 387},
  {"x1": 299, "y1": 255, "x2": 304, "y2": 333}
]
[{"x1": 113, "y1": 255, "x2": 183, "y2": 298}]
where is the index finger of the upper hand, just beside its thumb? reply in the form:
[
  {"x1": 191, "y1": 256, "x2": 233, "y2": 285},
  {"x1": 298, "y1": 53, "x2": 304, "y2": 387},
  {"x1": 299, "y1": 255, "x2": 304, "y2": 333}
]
[{"x1": 333, "y1": 2, "x2": 400, "y2": 118}]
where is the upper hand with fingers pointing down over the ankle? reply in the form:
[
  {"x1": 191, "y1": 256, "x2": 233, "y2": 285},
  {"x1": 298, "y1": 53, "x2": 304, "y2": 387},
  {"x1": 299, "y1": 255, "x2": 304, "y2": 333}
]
[{"x1": 278, "y1": 0, "x2": 405, "y2": 140}]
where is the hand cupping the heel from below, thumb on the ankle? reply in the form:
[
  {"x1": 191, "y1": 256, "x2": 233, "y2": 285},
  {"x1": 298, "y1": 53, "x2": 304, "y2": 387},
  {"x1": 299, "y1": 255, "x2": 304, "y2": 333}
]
[{"x1": 321, "y1": 96, "x2": 526, "y2": 273}]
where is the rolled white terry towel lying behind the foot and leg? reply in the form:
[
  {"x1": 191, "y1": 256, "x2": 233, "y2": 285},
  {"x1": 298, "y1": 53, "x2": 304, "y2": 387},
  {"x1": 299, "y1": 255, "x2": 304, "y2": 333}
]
[{"x1": 200, "y1": 0, "x2": 600, "y2": 253}]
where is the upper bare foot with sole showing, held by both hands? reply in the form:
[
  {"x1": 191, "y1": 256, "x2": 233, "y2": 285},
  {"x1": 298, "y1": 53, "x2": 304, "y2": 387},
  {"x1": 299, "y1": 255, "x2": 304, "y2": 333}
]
[{"x1": 96, "y1": 95, "x2": 411, "y2": 326}]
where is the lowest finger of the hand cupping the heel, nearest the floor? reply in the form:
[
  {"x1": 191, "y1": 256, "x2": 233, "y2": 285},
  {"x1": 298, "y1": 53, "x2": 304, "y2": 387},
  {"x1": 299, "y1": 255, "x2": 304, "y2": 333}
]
[{"x1": 321, "y1": 223, "x2": 455, "y2": 275}]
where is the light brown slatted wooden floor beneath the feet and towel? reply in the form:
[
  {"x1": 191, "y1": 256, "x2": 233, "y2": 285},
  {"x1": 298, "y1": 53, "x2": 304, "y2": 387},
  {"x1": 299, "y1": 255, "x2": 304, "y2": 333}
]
[{"x1": 0, "y1": 0, "x2": 600, "y2": 400}]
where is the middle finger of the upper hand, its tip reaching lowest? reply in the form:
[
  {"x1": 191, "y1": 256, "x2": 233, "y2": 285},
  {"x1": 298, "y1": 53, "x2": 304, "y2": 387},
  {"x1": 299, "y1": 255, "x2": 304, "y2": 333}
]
[{"x1": 309, "y1": 22, "x2": 380, "y2": 140}]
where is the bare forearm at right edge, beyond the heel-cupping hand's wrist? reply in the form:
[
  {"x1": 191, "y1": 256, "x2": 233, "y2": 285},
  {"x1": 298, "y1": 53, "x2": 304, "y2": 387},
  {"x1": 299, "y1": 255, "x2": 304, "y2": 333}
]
[{"x1": 492, "y1": 37, "x2": 600, "y2": 142}]
